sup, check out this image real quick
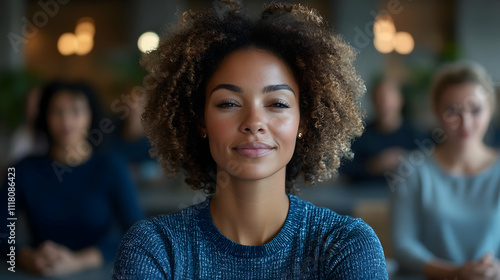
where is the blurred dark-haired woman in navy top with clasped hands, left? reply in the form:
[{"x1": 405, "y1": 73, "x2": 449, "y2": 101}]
[{"x1": 0, "y1": 82, "x2": 144, "y2": 276}]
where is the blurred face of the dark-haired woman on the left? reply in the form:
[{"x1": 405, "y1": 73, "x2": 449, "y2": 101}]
[{"x1": 47, "y1": 91, "x2": 92, "y2": 145}]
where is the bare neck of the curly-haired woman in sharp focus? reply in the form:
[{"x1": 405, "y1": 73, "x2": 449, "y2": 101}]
[{"x1": 210, "y1": 168, "x2": 289, "y2": 246}]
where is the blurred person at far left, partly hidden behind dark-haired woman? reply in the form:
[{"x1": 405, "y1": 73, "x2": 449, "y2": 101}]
[{"x1": 7, "y1": 86, "x2": 48, "y2": 164}]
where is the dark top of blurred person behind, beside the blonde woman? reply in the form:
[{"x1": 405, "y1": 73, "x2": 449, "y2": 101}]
[{"x1": 339, "y1": 121, "x2": 424, "y2": 184}]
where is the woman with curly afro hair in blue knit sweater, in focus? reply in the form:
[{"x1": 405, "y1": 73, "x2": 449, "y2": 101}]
[{"x1": 113, "y1": 2, "x2": 387, "y2": 279}]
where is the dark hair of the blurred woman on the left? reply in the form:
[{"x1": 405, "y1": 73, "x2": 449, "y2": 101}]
[{"x1": 35, "y1": 81, "x2": 103, "y2": 148}]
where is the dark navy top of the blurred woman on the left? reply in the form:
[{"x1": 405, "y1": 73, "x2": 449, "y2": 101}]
[{"x1": 0, "y1": 153, "x2": 144, "y2": 261}]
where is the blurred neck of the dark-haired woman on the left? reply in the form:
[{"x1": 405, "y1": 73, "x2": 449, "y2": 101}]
[{"x1": 50, "y1": 140, "x2": 92, "y2": 166}]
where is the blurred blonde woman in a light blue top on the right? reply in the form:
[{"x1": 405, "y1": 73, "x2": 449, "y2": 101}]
[{"x1": 391, "y1": 63, "x2": 500, "y2": 279}]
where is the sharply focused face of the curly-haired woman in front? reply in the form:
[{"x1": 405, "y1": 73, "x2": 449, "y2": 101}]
[{"x1": 203, "y1": 48, "x2": 300, "y2": 180}]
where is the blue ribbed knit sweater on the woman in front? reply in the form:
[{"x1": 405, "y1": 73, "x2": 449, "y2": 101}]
[{"x1": 113, "y1": 195, "x2": 388, "y2": 279}]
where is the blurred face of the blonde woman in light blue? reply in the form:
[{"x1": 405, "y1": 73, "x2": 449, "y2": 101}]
[{"x1": 436, "y1": 83, "x2": 492, "y2": 146}]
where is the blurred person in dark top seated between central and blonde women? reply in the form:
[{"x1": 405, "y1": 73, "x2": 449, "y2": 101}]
[{"x1": 340, "y1": 78, "x2": 423, "y2": 186}]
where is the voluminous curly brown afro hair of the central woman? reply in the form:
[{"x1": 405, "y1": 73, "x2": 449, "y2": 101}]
[{"x1": 141, "y1": 1, "x2": 365, "y2": 194}]
